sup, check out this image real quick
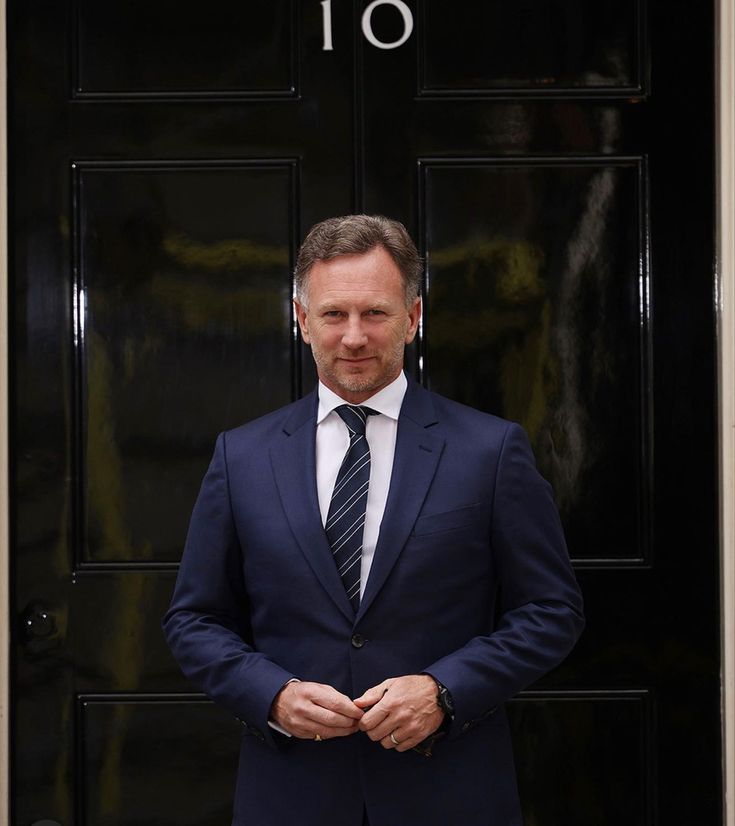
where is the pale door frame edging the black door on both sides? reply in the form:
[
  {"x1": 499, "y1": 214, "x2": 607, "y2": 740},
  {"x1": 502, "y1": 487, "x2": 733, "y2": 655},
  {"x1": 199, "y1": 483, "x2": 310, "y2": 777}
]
[{"x1": 0, "y1": 0, "x2": 735, "y2": 826}]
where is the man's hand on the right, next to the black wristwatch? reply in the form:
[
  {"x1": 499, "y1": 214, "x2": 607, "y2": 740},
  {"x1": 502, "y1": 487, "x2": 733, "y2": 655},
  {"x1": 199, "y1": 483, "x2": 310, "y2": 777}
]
[{"x1": 355, "y1": 674, "x2": 444, "y2": 751}]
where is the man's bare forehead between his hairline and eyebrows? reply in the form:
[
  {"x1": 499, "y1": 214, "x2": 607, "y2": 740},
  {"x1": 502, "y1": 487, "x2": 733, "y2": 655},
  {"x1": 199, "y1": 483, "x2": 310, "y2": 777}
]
[{"x1": 308, "y1": 247, "x2": 405, "y2": 303}]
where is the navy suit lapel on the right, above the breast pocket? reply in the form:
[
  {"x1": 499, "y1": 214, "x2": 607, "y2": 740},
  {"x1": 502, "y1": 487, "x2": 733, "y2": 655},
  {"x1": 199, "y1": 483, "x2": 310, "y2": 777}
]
[{"x1": 360, "y1": 381, "x2": 444, "y2": 619}]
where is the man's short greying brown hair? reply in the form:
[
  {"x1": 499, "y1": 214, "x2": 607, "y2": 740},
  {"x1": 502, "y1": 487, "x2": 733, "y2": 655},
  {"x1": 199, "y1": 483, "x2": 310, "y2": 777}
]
[{"x1": 294, "y1": 215, "x2": 421, "y2": 307}]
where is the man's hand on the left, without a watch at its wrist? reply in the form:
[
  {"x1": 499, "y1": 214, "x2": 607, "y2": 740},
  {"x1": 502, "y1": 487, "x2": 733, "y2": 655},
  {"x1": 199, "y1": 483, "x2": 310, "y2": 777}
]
[{"x1": 271, "y1": 681, "x2": 363, "y2": 740}]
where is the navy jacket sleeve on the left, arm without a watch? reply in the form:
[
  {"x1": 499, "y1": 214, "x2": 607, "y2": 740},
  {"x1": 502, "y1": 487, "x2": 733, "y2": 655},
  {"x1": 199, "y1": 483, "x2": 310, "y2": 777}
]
[{"x1": 163, "y1": 434, "x2": 294, "y2": 744}]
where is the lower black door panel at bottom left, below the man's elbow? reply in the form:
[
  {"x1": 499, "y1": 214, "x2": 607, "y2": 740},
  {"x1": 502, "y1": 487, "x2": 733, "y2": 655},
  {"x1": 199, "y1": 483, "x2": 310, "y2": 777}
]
[{"x1": 77, "y1": 694, "x2": 241, "y2": 826}]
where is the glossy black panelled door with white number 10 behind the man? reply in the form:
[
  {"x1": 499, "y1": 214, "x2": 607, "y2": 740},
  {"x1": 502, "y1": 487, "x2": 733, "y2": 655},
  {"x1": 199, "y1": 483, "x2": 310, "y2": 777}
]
[{"x1": 8, "y1": 0, "x2": 721, "y2": 826}]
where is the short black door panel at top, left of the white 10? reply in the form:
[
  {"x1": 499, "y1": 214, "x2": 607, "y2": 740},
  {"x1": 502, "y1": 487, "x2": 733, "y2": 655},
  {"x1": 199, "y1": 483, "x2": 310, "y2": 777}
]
[{"x1": 72, "y1": 0, "x2": 298, "y2": 99}]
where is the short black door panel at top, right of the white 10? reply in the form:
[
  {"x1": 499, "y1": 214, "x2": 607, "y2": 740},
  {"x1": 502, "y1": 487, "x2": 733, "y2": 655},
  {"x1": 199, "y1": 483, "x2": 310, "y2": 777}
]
[{"x1": 419, "y1": 0, "x2": 645, "y2": 97}]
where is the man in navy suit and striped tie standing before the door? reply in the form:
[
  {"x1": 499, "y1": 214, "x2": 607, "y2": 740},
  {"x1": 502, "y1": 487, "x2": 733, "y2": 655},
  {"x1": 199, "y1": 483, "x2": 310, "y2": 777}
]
[{"x1": 164, "y1": 216, "x2": 583, "y2": 826}]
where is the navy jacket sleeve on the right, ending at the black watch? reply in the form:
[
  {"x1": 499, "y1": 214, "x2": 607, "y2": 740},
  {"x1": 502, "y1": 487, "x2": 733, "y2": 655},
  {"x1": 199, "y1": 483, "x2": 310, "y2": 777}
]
[{"x1": 425, "y1": 424, "x2": 584, "y2": 737}]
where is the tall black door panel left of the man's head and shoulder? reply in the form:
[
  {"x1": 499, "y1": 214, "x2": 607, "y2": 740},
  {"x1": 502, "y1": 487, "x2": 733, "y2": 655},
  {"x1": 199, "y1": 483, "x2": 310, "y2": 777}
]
[{"x1": 74, "y1": 161, "x2": 298, "y2": 567}]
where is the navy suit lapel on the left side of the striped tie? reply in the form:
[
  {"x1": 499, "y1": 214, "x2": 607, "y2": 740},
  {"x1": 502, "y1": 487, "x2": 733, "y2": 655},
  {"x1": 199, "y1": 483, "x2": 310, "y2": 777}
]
[{"x1": 270, "y1": 392, "x2": 355, "y2": 620}]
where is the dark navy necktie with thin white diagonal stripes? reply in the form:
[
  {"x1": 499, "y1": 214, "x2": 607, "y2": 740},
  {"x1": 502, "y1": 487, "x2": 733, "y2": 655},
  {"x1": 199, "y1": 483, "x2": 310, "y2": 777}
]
[{"x1": 324, "y1": 404, "x2": 377, "y2": 611}]
